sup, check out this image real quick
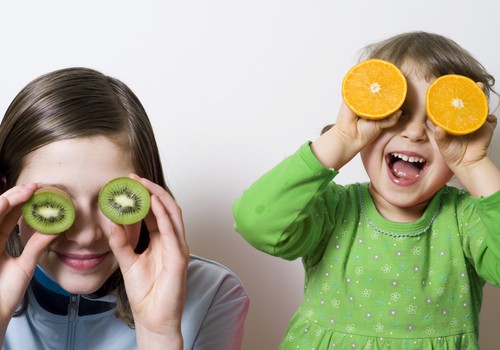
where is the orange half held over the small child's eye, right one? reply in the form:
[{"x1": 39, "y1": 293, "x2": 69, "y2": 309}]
[{"x1": 426, "y1": 74, "x2": 488, "y2": 135}]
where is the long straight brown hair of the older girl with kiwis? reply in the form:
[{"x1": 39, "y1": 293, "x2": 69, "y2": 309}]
[{"x1": 0, "y1": 67, "x2": 170, "y2": 326}]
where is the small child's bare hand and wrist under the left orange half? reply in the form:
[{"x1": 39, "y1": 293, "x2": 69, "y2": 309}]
[{"x1": 311, "y1": 103, "x2": 401, "y2": 170}]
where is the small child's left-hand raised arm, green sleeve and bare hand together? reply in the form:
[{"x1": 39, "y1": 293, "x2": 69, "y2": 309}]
[{"x1": 233, "y1": 105, "x2": 400, "y2": 259}]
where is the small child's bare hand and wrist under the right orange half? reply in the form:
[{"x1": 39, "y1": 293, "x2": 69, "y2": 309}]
[{"x1": 435, "y1": 115, "x2": 500, "y2": 197}]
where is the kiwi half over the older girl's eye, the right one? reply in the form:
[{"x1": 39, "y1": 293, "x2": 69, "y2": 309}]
[{"x1": 98, "y1": 177, "x2": 151, "y2": 225}]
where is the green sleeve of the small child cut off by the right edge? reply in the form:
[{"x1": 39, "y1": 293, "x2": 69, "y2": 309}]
[{"x1": 469, "y1": 191, "x2": 500, "y2": 286}]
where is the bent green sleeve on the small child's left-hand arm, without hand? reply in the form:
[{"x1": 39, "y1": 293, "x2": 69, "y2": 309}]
[{"x1": 232, "y1": 143, "x2": 337, "y2": 260}]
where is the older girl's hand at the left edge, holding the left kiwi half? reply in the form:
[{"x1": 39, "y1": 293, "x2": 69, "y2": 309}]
[{"x1": 0, "y1": 184, "x2": 57, "y2": 339}]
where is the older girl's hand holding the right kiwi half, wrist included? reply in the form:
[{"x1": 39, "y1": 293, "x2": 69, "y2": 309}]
[{"x1": 109, "y1": 176, "x2": 189, "y2": 349}]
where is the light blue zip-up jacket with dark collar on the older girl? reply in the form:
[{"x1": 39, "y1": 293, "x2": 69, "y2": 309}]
[{"x1": 2, "y1": 256, "x2": 249, "y2": 350}]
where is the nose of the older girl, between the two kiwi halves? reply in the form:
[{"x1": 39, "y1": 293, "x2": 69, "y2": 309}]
[{"x1": 65, "y1": 203, "x2": 103, "y2": 247}]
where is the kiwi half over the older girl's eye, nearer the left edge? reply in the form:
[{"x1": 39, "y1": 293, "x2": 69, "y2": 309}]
[{"x1": 22, "y1": 187, "x2": 75, "y2": 235}]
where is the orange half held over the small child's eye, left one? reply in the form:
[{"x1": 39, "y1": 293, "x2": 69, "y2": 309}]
[{"x1": 342, "y1": 59, "x2": 408, "y2": 119}]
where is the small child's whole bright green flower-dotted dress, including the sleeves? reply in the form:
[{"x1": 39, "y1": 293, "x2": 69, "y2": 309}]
[{"x1": 233, "y1": 144, "x2": 500, "y2": 350}]
